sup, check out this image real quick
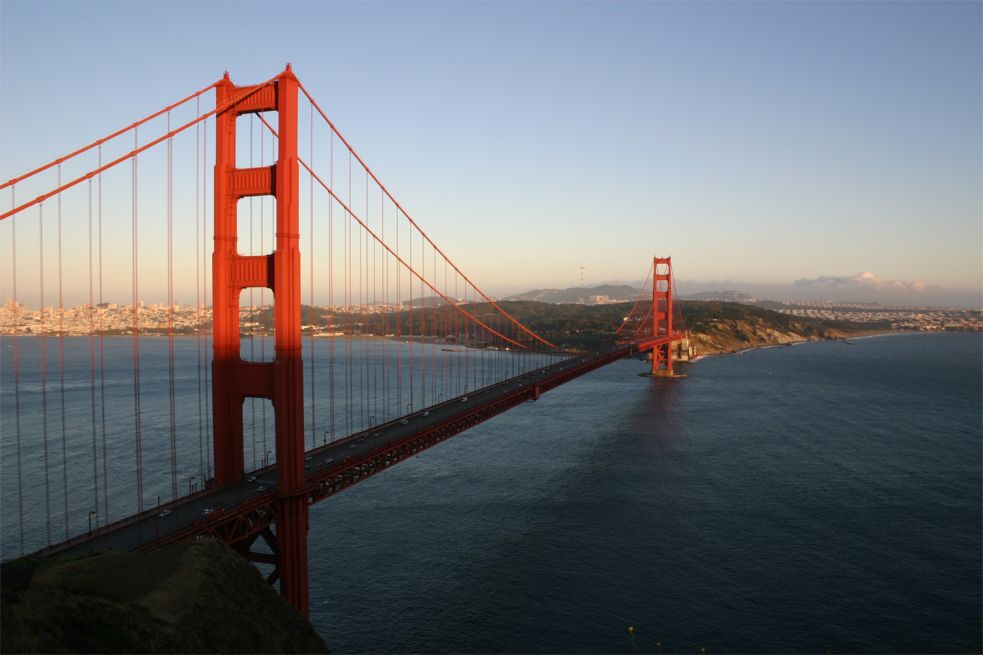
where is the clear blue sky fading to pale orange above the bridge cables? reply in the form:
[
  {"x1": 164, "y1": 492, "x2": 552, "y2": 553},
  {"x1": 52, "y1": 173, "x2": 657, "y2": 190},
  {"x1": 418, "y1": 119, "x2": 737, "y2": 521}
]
[{"x1": 0, "y1": 0, "x2": 983, "y2": 307}]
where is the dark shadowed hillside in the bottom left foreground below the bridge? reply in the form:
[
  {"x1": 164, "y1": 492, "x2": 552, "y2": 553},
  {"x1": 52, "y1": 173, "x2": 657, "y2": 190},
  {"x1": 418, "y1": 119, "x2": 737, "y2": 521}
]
[{"x1": 0, "y1": 540, "x2": 328, "y2": 653}]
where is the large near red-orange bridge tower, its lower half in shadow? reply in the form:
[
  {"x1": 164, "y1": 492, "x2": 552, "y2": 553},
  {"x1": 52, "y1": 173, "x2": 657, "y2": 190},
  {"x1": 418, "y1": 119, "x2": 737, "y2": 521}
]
[{"x1": 212, "y1": 64, "x2": 308, "y2": 616}]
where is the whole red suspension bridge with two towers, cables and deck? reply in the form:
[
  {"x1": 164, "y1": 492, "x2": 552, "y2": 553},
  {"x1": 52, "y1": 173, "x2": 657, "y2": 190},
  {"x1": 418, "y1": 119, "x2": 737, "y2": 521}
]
[{"x1": 0, "y1": 66, "x2": 684, "y2": 615}]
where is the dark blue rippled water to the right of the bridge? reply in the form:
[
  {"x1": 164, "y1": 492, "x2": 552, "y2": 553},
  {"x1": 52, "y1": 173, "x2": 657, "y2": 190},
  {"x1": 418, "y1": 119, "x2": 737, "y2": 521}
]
[{"x1": 309, "y1": 334, "x2": 983, "y2": 653}]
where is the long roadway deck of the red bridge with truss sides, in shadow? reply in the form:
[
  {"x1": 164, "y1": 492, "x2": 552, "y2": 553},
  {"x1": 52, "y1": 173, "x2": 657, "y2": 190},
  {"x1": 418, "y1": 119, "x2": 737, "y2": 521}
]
[{"x1": 41, "y1": 345, "x2": 637, "y2": 554}]
